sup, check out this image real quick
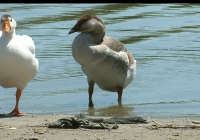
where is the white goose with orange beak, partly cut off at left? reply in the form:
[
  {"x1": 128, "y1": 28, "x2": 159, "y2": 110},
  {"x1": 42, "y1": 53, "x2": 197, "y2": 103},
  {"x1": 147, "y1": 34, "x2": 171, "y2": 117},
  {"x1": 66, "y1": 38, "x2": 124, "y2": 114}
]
[{"x1": 0, "y1": 14, "x2": 39, "y2": 116}]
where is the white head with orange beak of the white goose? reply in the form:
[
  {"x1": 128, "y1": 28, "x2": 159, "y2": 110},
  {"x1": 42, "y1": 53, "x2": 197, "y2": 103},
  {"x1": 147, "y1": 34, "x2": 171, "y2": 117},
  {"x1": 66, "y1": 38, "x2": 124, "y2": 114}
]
[{"x1": 0, "y1": 14, "x2": 17, "y2": 34}]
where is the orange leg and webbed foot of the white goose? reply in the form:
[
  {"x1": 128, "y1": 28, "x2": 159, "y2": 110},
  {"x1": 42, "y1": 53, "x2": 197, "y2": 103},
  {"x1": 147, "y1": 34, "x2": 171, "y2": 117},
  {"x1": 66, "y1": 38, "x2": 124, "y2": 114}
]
[{"x1": 9, "y1": 90, "x2": 26, "y2": 116}]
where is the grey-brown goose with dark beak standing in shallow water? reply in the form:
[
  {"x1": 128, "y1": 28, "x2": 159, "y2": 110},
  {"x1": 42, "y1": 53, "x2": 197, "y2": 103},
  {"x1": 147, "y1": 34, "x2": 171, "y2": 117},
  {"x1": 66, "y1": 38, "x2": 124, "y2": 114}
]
[{"x1": 69, "y1": 15, "x2": 136, "y2": 106}]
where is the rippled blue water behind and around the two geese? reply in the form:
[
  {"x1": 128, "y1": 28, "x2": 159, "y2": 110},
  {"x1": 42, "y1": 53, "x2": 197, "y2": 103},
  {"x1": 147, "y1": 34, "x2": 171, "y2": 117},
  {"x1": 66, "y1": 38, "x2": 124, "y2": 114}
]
[{"x1": 0, "y1": 4, "x2": 200, "y2": 117}]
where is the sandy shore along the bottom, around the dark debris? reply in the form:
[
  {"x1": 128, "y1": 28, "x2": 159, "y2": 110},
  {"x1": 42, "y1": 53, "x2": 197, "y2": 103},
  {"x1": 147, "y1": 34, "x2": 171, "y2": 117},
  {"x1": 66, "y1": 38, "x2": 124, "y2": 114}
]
[{"x1": 0, "y1": 114, "x2": 200, "y2": 140}]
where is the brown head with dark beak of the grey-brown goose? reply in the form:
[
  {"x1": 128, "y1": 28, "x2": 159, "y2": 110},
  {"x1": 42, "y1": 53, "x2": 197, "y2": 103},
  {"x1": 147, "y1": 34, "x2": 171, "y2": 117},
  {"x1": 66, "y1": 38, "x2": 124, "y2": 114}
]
[{"x1": 68, "y1": 15, "x2": 106, "y2": 42}]
